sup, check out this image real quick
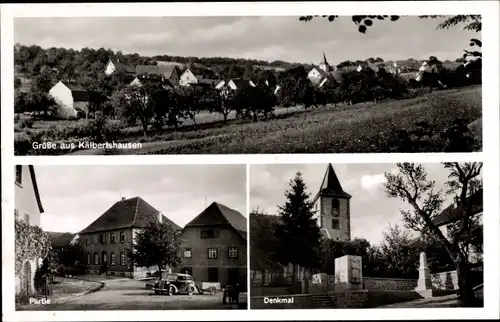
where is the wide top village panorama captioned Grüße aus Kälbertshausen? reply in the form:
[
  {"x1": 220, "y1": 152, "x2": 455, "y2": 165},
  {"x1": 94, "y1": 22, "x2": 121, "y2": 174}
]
[{"x1": 13, "y1": 15, "x2": 482, "y2": 155}]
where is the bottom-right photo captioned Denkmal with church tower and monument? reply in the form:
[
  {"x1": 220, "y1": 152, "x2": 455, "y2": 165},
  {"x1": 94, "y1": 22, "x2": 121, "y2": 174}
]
[{"x1": 249, "y1": 163, "x2": 483, "y2": 310}]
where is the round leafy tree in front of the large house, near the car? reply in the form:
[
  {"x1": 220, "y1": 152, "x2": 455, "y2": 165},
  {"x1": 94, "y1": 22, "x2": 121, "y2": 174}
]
[{"x1": 127, "y1": 220, "x2": 182, "y2": 278}]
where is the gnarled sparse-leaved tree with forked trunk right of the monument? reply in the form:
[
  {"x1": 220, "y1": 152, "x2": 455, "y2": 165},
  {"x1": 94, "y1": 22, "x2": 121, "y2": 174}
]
[{"x1": 384, "y1": 162, "x2": 482, "y2": 307}]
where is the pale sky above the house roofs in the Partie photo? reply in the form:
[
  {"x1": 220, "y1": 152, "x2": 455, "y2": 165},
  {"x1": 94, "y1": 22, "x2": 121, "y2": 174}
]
[{"x1": 35, "y1": 165, "x2": 247, "y2": 233}]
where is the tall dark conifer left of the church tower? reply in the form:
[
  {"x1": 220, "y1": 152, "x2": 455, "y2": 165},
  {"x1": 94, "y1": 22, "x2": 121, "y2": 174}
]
[{"x1": 275, "y1": 172, "x2": 321, "y2": 283}]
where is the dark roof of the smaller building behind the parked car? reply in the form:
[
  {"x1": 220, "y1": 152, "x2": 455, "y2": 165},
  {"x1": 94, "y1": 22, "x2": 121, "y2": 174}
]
[{"x1": 183, "y1": 202, "x2": 247, "y2": 240}]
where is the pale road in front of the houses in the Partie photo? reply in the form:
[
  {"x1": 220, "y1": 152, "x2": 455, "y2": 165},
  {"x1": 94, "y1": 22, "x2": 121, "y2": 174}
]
[{"x1": 19, "y1": 280, "x2": 235, "y2": 311}]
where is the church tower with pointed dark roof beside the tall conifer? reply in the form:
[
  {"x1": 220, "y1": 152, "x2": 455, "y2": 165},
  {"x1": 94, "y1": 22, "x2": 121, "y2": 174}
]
[{"x1": 313, "y1": 164, "x2": 351, "y2": 241}]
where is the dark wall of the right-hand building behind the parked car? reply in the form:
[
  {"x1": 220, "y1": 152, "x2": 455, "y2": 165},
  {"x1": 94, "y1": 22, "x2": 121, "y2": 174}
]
[{"x1": 179, "y1": 226, "x2": 247, "y2": 286}]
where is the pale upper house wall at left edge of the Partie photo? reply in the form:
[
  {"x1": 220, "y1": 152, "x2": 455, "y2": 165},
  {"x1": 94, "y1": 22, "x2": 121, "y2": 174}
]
[{"x1": 14, "y1": 165, "x2": 40, "y2": 226}]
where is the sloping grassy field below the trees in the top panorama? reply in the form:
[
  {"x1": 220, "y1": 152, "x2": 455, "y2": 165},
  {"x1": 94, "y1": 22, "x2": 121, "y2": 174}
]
[{"x1": 15, "y1": 86, "x2": 482, "y2": 154}]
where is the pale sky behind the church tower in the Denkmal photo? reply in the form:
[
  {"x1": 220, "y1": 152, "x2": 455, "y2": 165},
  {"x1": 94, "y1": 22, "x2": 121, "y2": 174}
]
[{"x1": 250, "y1": 163, "x2": 480, "y2": 245}]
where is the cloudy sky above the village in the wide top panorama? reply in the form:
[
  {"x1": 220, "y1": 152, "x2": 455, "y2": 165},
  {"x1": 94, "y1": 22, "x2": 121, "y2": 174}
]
[{"x1": 14, "y1": 16, "x2": 481, "y2": 65}]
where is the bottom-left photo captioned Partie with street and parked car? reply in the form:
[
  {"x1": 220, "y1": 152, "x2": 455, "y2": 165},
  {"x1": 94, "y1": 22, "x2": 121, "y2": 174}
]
[{"x1": 14, "y1": 165, "x2": 248, "y2": 311}]
